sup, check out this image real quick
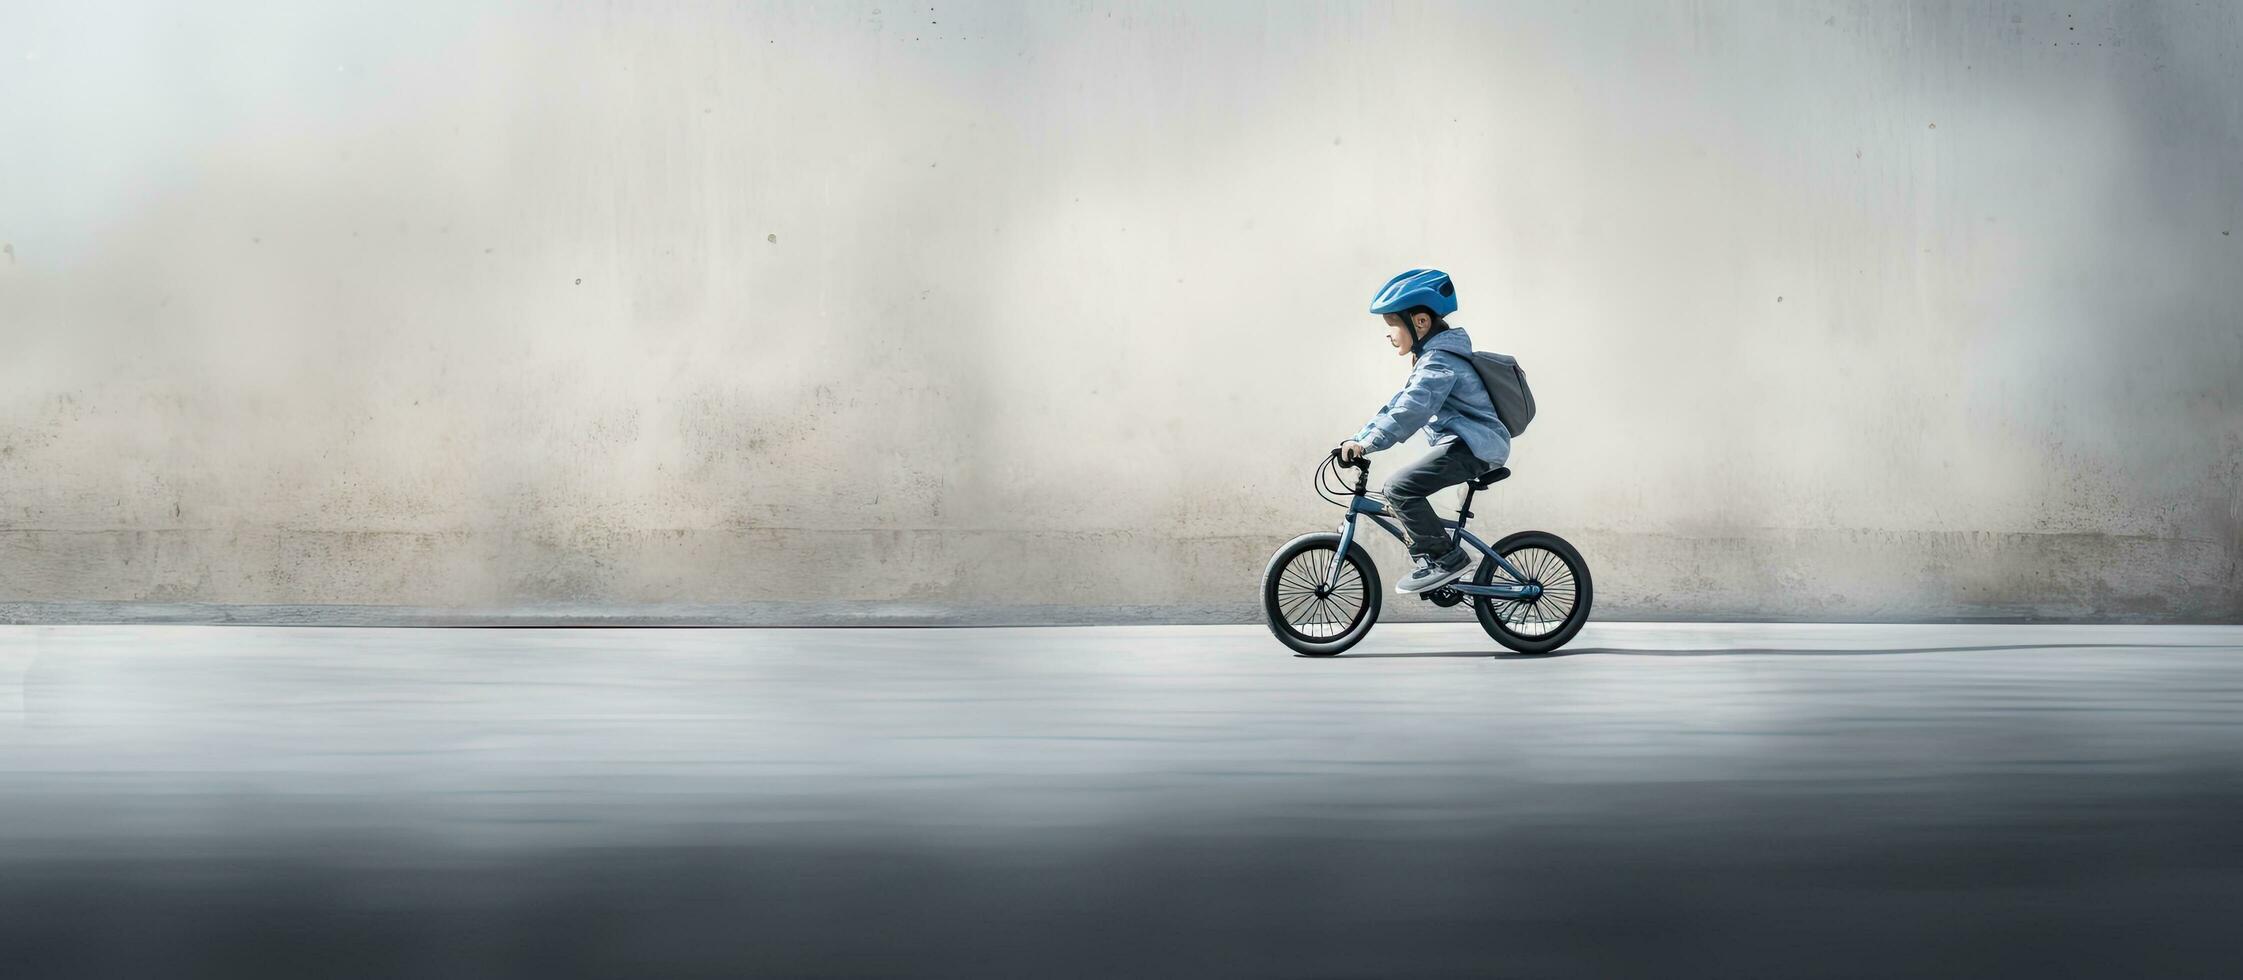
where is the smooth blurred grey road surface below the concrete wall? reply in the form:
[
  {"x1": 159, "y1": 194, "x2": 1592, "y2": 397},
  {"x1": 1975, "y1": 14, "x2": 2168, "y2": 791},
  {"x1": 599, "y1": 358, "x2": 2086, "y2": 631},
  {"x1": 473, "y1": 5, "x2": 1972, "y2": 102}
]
[{"x1": 0, "y1": 623, "x2": 2243, "y2": 978}]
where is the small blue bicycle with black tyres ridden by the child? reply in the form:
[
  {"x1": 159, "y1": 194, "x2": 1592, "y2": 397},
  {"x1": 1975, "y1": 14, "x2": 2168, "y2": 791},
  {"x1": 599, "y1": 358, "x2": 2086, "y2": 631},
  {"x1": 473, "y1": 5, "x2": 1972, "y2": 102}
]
[{"x1": 1263, "y1": 449, "x2": 1593, "y2": 657}]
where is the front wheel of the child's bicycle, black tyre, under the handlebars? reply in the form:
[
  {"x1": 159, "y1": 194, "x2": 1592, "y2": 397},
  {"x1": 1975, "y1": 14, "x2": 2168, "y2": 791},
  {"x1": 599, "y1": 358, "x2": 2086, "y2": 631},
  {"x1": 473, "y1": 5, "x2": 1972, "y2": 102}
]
[{"x1": 1263, "y1": 531, "x2": 1379, "y2": 657}]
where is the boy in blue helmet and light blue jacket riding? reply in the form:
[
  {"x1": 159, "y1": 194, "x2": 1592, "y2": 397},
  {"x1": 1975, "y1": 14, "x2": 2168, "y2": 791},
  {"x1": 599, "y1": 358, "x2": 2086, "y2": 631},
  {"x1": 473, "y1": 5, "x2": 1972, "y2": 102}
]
[{"x1": 1339, "y1": 269, "x2": 1512, "y2": 592}]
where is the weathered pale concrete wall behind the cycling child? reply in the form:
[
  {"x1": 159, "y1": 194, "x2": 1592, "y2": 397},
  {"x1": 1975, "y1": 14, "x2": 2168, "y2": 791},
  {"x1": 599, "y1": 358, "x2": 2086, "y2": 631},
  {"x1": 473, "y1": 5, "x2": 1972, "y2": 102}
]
[{"x1": 0, "y1": 0, "x2": 2243, "y2": 621}]
